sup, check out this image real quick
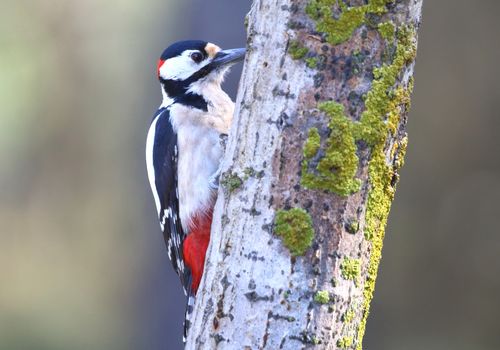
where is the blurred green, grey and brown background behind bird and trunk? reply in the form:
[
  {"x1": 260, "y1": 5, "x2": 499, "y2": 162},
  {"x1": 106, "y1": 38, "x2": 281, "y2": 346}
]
[{"x1": 0, "y1": 0, "x2": 500, "y2": 350}]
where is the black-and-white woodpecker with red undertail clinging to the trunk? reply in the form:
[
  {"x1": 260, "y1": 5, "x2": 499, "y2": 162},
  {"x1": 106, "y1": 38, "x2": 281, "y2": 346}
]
[{"x1": 146, "y1": 40, "x2": 245, "y2": 340}]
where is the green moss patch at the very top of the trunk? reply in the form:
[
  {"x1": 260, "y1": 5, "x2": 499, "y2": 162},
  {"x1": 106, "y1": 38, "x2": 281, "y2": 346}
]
[{"x1": 306, "y1": 0, "x2": 394, "y2": 45}]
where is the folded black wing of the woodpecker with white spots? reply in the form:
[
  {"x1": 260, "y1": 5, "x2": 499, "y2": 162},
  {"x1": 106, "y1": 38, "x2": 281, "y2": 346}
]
[{"x1": 153, "y1": 108, "x2": 191, "y2": 294}]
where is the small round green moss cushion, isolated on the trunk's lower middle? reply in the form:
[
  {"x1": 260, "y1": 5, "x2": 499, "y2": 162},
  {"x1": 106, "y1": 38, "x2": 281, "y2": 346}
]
[{"x1": 275, "y1": 208, "x2": 314, "y2": 256}]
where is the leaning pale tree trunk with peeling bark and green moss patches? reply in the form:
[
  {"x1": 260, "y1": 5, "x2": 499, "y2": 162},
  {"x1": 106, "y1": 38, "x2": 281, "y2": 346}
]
[{"x1": 186, "y1": 0, "x2": 422, "y2": 349}]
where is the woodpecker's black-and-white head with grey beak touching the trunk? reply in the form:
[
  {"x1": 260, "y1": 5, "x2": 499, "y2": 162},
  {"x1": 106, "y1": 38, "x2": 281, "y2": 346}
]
[{"x1": 158, "y1": 40, "x2": 245, "y2": 105}]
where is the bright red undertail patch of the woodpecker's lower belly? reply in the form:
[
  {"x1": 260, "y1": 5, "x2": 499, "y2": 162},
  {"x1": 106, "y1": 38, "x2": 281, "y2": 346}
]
[{"x1": 182, "y1": 210, "x2": 212, "y2": 294}]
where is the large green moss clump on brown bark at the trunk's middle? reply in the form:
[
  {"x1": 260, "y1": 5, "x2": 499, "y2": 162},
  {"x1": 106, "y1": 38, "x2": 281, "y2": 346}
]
[{"x1": 301, "y1": 101, "x2": 361, "y2": 196}]
